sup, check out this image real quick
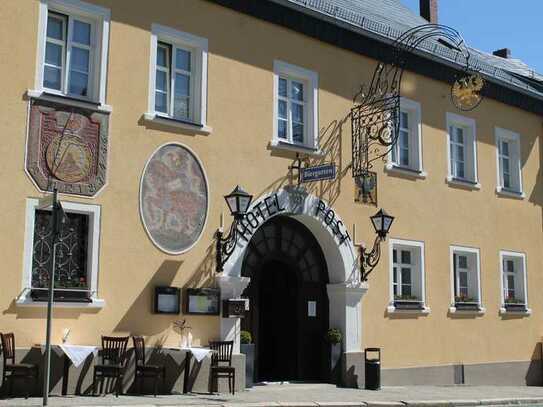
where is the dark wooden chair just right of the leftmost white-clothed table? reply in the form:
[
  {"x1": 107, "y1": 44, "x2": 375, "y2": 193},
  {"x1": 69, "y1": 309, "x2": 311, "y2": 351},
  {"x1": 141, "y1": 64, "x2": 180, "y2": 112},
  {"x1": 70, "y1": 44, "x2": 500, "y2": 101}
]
[{"x1": 92, "y1": 336, "x2": 128, "y2": 397}]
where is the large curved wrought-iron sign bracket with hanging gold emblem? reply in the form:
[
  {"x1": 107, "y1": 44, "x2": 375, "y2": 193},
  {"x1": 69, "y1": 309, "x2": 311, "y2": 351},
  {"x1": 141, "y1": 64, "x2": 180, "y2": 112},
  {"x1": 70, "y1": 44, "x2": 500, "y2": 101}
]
[{"x1": 351, "y1": 24, "x2": 484, "y2": 182}]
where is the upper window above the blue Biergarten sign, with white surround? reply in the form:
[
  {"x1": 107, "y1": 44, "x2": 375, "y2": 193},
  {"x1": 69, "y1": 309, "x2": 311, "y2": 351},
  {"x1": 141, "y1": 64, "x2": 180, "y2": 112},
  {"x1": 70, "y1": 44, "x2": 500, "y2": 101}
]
[{"x1": 272, "y1": 61, "x2": 318, "y2": 150}]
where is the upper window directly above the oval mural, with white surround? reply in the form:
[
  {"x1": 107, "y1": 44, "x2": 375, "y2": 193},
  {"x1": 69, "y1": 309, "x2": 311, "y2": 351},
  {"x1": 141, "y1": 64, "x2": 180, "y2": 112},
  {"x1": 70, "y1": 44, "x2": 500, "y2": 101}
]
[{"x1": 145, "y1": 24, "x2": 208, "y2": 127}]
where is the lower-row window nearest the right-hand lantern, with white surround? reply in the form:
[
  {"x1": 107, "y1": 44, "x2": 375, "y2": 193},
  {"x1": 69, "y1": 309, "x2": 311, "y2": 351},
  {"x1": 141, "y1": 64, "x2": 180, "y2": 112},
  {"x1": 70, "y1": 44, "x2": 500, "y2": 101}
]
[{"x1": 388, "y1": 239, "x2": 428, "y2": 312}]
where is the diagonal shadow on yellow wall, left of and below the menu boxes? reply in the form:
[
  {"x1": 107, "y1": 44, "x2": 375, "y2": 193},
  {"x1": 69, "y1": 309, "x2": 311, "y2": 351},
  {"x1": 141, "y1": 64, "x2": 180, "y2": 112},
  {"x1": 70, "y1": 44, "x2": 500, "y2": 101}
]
[{"x1": 114, "y1": 260, "x2": 183, "y2": 336}]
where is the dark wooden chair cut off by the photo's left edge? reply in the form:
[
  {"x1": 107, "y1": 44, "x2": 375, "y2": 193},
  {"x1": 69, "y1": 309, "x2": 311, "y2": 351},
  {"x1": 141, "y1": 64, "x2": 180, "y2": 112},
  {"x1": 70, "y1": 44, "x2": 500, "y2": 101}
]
[{"x1": 0, "y1": 333, "x2": 39, "y2": 398}]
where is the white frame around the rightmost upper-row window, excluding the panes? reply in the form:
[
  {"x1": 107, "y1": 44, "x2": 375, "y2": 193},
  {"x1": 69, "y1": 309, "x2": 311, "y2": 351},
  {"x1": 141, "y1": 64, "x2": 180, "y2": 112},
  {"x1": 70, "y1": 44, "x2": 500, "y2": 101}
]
[{"x1": 494, "y1": 127, "x2": 526, "y2": 199}]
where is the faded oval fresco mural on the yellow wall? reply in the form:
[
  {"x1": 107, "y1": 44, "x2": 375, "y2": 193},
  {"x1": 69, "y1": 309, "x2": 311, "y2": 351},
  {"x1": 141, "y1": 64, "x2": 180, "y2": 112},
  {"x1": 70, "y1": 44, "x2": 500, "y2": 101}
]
[{"x1": 140, "y1": 143, "x2": 208, "y2": 254}]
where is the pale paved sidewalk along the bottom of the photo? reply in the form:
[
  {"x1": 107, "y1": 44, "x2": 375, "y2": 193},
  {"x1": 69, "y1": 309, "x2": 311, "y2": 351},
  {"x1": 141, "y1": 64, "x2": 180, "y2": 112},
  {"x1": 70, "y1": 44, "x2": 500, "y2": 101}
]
[{"x1": 0, "y1": 384, "x2": 543, "y2": 407}]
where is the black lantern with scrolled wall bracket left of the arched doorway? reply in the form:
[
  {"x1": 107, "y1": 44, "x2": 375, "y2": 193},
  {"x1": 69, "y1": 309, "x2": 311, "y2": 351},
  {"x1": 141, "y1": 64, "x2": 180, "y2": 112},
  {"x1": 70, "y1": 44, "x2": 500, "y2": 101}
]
[{"x1": 216, "y1": 185, "x2": 253, "y2": 273}]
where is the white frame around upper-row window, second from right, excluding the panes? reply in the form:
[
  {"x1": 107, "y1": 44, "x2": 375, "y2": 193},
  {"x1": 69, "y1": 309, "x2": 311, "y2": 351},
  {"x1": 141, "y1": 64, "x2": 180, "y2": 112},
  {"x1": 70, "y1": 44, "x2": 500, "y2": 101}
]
[{"x1": 446, "y1": 113, "x2": 481, "y2": 189}]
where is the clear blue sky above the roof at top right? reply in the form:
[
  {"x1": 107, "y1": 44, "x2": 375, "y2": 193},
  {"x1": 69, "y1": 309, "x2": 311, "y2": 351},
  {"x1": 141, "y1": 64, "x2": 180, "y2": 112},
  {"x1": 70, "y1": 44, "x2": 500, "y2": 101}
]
[{"x1": 401, "y1": 0, "x2": 543, "y2": 73}]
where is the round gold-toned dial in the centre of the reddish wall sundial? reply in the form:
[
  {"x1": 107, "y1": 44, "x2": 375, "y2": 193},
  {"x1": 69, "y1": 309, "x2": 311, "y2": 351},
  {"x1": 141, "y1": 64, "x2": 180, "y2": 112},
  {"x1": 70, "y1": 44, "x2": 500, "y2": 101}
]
[{"x1": 46, "y1": 136, "x2": 92, "y2": 182}]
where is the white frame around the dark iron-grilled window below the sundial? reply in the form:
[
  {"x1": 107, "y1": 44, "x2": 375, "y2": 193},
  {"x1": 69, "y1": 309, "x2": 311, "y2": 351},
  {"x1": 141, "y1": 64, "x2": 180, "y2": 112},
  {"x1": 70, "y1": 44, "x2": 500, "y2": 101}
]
[{"x1": 16, "y1": 198, "x2": 105, "y2": 308}]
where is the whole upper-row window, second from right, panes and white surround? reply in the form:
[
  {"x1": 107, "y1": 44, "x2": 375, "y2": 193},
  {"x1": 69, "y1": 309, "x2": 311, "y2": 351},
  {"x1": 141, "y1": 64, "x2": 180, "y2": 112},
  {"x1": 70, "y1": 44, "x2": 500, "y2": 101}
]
[{"x1": 447, "y1": 113, "x2": 479, "y2": 187}]
